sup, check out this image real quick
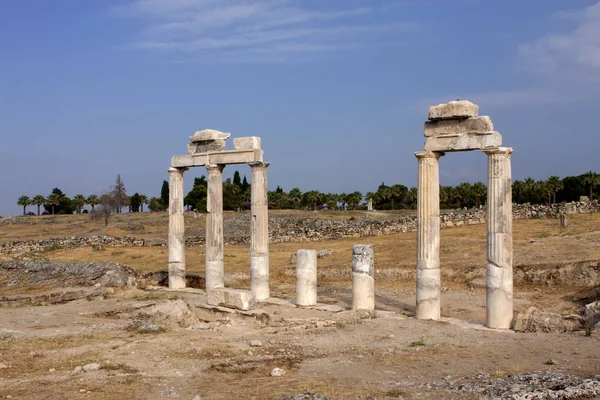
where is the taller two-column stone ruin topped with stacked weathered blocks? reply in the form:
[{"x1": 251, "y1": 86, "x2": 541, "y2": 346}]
[{"x1": 415, "y1": 100, "x2": 513, "y2": 329}]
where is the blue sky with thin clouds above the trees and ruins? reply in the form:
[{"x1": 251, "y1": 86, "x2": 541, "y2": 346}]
[{"x1": 0, "y1": 0, "x2": 600, "y2": 216}]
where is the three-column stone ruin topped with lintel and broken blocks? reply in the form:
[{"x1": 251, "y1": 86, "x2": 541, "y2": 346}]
[{"x1": 168, "y1": 129, "x2": 269, "y2": 304}]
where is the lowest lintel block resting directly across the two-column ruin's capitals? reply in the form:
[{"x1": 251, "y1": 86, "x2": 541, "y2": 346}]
[{"x1": 425, "y1": 132, "x2": 502, "y2": 152}]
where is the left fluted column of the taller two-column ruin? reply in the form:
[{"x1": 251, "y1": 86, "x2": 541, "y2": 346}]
[{"x1": 415, "y1": 151, "x2": 444, "y2": 320}]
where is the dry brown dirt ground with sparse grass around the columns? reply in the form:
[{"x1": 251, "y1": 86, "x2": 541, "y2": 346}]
[{"x1": 0, "y1": 214, "x2": 600, "y2": 399}]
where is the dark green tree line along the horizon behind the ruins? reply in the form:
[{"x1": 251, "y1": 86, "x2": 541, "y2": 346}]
[{"x1": 12, "y1": 171, "x2": 600, "y2": 215}]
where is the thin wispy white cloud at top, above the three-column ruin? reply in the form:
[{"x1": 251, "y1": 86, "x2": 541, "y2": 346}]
[{"x1": 112, "y1": 0, "x2": 418, "y2": 62}]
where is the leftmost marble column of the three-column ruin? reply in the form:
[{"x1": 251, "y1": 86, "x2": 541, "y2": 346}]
[{"x1": 168, "y1": 168, "x2": 187, "y2": 289}]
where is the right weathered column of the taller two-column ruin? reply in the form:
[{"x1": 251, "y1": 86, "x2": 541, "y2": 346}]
[{"x1": 483, "y1": 147, "x2": 513, "y2": 329}]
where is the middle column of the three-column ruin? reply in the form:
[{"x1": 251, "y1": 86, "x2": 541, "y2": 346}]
[{"x1": 206, "y1": 165, "x2": 225, "y2": 289}]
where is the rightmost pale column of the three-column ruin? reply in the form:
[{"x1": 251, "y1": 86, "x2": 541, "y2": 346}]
[{"x1": 250, "y1": 162, "x2": 270, "y2": 301}]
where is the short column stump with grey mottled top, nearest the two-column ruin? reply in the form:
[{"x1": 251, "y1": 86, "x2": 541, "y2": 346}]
[{"x1": 352, "y1": 244, "x2": 375, "y2": 310}]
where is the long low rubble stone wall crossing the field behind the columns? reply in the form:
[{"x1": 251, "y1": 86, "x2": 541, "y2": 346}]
[{"x1": 0, "y1": 200, "x2": 600, "y2": 255}]
